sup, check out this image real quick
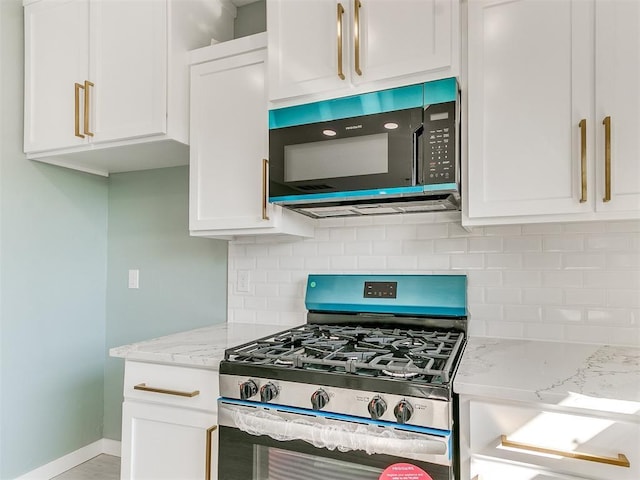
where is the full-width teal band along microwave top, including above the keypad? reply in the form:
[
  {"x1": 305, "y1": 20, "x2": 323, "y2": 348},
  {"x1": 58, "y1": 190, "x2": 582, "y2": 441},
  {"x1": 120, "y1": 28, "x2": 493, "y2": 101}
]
[{"x1": 269, "y1": 78, "x2": 458, "y2": 130}]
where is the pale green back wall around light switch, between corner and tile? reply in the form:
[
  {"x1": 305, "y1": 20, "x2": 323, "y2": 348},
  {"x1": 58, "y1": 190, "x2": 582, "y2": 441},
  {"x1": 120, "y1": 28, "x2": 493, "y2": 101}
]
[{"x1": 104, "y1": 167, "x2": 227, "y2": 440}]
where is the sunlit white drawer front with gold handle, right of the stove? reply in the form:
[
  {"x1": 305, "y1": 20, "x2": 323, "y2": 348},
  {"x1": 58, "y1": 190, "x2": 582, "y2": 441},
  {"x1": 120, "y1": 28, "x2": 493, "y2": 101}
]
[{"x1": 470, "y1": 401, "x2": 640, "y2": 480}]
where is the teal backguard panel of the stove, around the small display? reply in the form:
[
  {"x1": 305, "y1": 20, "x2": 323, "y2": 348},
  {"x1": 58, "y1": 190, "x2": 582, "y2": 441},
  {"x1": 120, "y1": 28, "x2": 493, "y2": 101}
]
[{"x1": 305, "y1": 274, "x2": 467, "y2": 317}]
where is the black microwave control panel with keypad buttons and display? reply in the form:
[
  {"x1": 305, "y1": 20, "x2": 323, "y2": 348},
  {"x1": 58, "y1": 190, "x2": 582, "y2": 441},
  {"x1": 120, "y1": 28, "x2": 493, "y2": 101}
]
[{"x1": 422, "y1": 102, "x2": 457, "y2": 185}]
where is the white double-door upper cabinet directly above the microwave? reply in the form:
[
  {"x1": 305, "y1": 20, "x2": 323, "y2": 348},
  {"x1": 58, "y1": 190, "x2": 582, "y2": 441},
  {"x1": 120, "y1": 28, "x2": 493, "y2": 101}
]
[{"x1": 267, "y1": 0, "x2": 460, "y2": 104}]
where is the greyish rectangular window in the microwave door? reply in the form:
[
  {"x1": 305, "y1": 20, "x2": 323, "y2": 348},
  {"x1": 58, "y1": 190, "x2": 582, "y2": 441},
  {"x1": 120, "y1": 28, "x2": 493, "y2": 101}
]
[{"x1": 284, "y1": 133, "x2": 389, "y2": 182}]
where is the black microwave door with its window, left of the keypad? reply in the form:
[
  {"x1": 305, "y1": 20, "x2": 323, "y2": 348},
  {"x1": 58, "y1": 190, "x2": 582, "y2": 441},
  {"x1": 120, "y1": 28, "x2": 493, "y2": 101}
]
[{"x1": 269, "y1": 108, "x2": 423, "y2": 197}]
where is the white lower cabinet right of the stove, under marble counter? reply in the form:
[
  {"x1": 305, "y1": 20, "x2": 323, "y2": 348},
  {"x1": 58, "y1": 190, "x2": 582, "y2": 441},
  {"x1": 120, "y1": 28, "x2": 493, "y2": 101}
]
[{"x1": 461, "y1": 399, "x2": 640, "y2": 480}]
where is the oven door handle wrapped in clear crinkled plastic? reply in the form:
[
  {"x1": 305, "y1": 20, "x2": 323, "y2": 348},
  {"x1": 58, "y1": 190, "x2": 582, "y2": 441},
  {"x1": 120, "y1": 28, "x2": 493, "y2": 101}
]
[{"x1": 219, "y1": 403, "x2": 449, "y2": 457}]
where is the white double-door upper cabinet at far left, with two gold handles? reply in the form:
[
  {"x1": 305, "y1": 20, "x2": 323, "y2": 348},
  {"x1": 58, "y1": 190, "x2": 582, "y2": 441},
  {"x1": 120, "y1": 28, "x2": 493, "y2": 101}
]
[{"x1": 24, "y1": 0, "x2": 235, "y2": 175}]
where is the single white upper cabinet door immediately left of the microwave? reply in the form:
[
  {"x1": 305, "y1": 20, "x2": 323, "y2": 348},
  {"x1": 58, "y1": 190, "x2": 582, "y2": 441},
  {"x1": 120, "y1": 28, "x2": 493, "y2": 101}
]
[{"x1": 190, "y1": 50, "x2": 269, "y2": 230}]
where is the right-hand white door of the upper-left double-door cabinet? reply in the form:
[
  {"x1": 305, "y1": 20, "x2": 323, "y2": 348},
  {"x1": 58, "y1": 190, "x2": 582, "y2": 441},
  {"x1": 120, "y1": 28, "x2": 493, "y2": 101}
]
[{"x1": 88, "y1": 1, "x2": 167, "y2": 143}]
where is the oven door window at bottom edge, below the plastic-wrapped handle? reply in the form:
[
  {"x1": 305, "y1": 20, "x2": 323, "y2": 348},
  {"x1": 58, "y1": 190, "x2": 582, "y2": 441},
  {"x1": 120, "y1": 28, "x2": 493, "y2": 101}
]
[{"x1": 253, "y1": 445, "x2": 382, "y2": 480}]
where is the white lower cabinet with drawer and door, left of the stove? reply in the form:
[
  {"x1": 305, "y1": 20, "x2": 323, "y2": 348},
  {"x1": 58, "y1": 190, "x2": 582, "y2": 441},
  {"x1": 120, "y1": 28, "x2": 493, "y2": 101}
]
[{"x1": 121, "y1": 361, "x2": 218, "y2": 480}]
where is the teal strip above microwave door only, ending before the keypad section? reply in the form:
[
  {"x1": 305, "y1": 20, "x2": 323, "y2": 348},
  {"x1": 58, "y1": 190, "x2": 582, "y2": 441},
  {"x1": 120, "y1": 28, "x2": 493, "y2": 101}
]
[{"x1": 269, "y1": 85, "x2": 423, "y2": 129}]
